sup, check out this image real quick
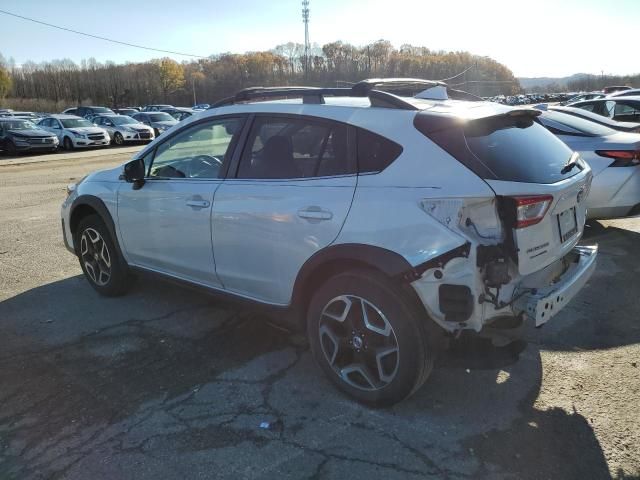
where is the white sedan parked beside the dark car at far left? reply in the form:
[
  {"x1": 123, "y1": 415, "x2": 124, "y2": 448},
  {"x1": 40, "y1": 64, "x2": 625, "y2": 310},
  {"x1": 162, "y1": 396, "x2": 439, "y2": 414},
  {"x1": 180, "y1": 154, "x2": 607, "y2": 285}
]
[{"x1": 38, "y1": 115, "x2": 111, "y2": 150}]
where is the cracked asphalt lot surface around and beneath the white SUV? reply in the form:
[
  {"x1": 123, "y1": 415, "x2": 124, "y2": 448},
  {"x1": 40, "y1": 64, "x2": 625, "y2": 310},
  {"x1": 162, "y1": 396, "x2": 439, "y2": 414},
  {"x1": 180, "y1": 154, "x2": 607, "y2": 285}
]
[{"x1": 0, "y1": 149, "x2": 640, "y2": 480}]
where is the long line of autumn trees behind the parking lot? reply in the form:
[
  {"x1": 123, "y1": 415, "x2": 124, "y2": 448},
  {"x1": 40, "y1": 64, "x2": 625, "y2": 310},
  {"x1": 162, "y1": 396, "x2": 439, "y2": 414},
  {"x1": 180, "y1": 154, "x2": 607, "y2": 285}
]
[{"x1": 0, "y1": 40, "x2": 520, "y2": 108}]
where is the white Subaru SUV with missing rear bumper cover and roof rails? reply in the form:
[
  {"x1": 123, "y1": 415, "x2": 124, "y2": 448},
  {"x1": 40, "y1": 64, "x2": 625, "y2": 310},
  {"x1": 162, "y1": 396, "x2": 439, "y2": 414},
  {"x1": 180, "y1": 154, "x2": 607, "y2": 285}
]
[{"x1": 62, "y1": 79, "x2": 597, "y2": 405}]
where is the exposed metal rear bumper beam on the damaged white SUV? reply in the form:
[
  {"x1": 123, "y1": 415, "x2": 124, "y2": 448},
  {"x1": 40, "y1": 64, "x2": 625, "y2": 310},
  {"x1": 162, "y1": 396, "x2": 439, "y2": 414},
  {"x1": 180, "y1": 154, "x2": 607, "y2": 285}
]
[{"x1": 513, "y1": 245, "x2": 598, "y2": 327}]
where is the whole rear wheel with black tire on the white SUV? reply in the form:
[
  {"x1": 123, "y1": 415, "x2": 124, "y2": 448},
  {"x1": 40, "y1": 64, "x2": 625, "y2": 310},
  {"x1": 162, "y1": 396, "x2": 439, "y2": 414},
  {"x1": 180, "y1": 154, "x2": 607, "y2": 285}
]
[{"x1": 307, "y1": 269, "x2": 440, "y2": 407}]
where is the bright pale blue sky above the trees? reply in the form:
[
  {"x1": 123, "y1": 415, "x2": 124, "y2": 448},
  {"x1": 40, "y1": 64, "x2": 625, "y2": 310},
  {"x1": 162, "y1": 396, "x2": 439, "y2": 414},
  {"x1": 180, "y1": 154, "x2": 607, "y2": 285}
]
[{"x1": 0, "y1": 0, "x2": 640, "y2": 76}]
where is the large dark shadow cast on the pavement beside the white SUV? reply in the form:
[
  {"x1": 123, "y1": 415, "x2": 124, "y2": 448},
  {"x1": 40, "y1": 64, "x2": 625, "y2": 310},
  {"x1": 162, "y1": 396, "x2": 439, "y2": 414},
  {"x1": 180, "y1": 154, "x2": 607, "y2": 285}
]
[{"x1": 0, "y1": 264, "x2": 620, "y2": 479}]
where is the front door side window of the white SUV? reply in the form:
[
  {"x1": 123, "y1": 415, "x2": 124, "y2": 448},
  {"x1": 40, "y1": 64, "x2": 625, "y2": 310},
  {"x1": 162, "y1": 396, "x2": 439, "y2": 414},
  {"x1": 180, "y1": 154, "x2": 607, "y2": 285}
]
[{"x1": 149, "y1": 118, "x2": 243, "y2": 178}]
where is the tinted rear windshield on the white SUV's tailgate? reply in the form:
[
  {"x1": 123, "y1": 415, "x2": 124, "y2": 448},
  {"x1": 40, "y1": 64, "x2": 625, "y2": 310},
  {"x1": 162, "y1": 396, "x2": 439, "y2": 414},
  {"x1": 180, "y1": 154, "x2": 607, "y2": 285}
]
[{"x1": 464, "y1": 117, "x2": 580, "y2": 183}]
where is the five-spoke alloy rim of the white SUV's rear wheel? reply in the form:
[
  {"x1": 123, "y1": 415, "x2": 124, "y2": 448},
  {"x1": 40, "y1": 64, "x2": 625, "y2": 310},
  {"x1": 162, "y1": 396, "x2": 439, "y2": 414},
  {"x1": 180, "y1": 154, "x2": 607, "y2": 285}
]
[{"x1": 318, "y1": 295, "x2": 400, "y2": 391}]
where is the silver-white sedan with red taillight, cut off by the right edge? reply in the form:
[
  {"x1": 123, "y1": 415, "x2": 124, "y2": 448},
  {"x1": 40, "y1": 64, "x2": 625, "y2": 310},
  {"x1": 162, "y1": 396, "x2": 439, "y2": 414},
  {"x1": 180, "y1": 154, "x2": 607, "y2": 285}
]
[{"x1": 538, "y1": 110, "x2": 640, "y2": 219}]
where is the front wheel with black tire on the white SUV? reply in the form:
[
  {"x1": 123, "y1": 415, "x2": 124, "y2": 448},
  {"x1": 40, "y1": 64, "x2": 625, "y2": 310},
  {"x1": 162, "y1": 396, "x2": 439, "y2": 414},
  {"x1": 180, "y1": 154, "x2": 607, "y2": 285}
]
[{"x1": 74, "y1": 215, "x2": 132, "y2": 297}]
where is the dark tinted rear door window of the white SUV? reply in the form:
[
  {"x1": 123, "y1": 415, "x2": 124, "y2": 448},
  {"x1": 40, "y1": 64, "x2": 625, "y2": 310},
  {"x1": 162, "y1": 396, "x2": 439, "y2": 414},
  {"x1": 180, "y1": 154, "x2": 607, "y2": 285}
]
[{"x1": 238, "y1": 117, "x2": 354, "y2": 179}]
